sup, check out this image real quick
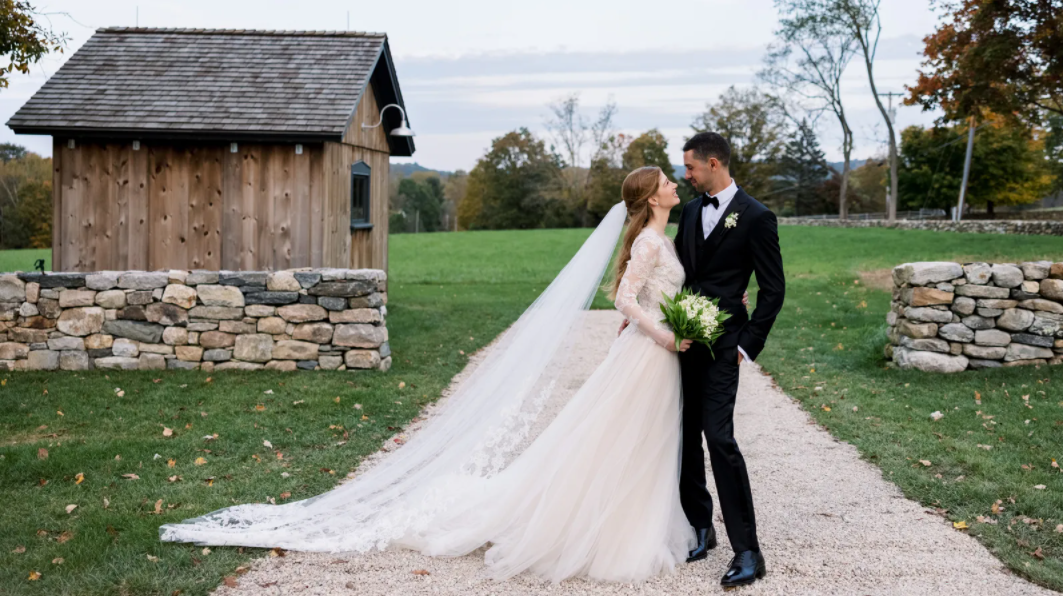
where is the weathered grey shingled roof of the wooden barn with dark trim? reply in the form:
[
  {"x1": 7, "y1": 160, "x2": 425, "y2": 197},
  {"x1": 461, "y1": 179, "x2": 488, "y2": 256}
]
[{"x1": 7, "y1": 28, "x2": 414, "y2": 155}]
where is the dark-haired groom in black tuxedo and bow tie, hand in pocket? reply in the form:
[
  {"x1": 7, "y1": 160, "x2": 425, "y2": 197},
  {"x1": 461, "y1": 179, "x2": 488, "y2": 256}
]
[{"x1": 675, "y1": 133, "x2": 786, "y2": 586}]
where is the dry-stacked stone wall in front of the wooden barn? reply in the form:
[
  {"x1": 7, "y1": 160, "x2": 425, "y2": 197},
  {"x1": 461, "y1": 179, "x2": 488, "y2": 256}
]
[{"x1": 0, "y1": 269, "x2": 391, "y2": 371}]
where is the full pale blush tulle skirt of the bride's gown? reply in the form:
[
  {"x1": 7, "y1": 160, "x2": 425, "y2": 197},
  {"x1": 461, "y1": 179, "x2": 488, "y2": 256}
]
[{"x1": 396, "y1": 326, "x2": 694, "y2": 582}]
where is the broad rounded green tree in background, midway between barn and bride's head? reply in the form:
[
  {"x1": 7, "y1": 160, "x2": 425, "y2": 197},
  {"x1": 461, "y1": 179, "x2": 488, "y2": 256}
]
[{"x1": 458, "y1": 129, "x2": 564, "y2": 229}]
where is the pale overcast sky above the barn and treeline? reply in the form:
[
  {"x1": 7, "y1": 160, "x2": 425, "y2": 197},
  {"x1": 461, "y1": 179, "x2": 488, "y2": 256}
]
[{"x1": 0, "y1": 0, "x2": 937, "y2": 170}]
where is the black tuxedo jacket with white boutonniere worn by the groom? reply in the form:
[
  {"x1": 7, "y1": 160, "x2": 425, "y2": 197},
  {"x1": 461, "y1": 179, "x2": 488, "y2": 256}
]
[{"x1": 675, "y1": 188, "x2": 786, "y2": 359}]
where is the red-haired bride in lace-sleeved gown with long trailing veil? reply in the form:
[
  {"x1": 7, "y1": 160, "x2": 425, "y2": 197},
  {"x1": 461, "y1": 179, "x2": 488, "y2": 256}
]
[{"x1": 159, "y1": 167, "x2": 722, "y2": 582}]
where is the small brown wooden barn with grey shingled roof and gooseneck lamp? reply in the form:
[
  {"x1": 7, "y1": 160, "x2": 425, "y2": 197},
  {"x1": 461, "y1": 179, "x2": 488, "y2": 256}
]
[{"x1": 7, "y1": 29, "x2": 414, "y2": 271}]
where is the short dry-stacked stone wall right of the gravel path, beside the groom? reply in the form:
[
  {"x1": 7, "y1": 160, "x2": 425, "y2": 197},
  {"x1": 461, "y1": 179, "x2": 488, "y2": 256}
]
[{"x1": 887, "y1": 261, "x2": 1063, "y2": 373}]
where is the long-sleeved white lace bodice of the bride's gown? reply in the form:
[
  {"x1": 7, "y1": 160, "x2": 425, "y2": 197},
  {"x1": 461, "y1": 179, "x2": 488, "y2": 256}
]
[{"x1": 615, "y1": 227, "x2": 686, "y2": 345}]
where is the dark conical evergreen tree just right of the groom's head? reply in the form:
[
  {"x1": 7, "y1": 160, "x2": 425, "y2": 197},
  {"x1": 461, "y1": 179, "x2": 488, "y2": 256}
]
[{"x1": 778, "y1": 120, "x2": 832, "y2": 216}]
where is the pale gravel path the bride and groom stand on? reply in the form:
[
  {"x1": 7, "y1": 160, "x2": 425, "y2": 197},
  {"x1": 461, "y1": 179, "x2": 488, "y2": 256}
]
[{"x1": 215, "y1": 311, "x2": 1057, "y2": 596}]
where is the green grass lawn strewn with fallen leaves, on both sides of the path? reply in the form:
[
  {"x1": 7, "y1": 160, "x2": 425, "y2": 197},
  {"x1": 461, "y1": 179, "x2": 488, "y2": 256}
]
[{"x1": 0, "y1": 227, "x2": 1063, "y2": 595}]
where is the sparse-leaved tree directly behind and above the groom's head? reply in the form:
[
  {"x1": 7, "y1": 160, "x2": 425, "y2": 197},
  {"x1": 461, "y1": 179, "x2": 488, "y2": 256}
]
[{"x1": 691, "y1": 85, "x2": 786, "y2": 197}]
